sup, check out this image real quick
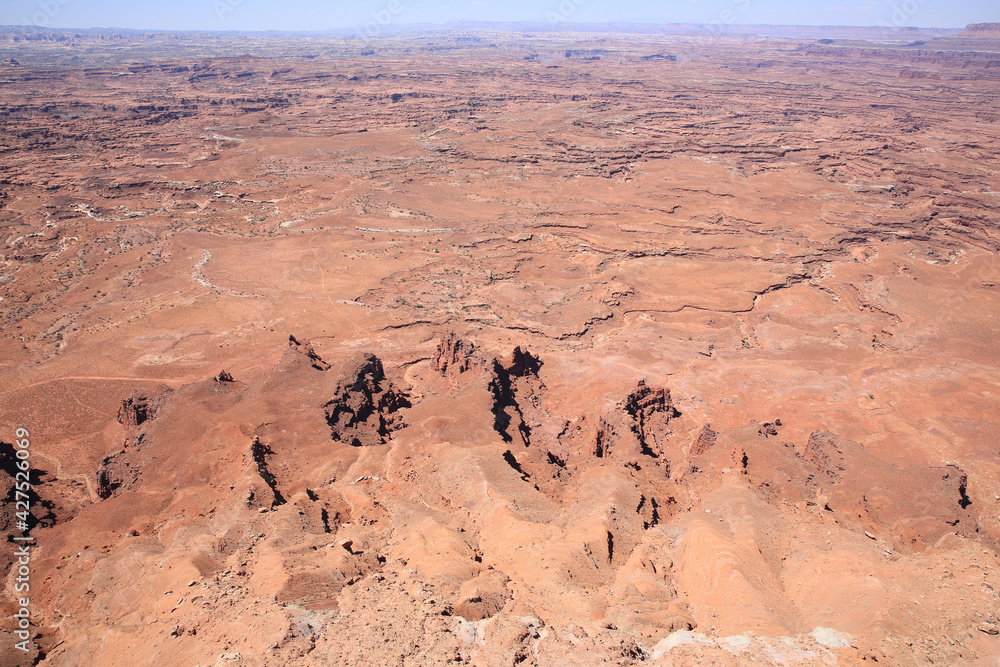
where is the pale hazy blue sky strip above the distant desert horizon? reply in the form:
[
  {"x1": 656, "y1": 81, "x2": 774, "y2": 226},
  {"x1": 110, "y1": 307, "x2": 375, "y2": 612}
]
[{"x1": 0, "y1": 0, "x2": 1000, "y2": 30}]
